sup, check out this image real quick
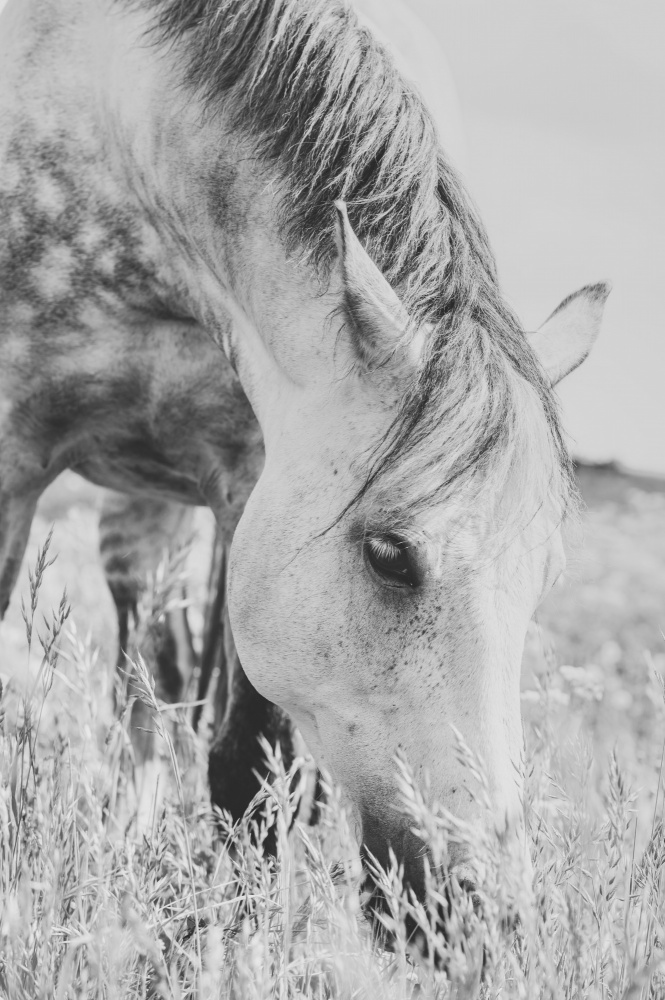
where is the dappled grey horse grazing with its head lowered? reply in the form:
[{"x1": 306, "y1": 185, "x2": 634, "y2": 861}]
[{"x1": 0, "y1": 0, "x2": 607, "y2": 908}]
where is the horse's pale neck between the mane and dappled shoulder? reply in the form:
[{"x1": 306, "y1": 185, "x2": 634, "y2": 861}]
[{"x1": 0, "y1": 0, "x2": 338, "y2": 433}]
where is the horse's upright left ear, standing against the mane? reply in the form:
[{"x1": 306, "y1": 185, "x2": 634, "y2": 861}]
[{"x1": 335, "y1": 201, "x2": 409, "y2": 368}]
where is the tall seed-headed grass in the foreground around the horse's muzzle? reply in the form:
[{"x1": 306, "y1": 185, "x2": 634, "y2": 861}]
[{"x1": 0, "y1": 540, "x2": 665, "y2": 1000}]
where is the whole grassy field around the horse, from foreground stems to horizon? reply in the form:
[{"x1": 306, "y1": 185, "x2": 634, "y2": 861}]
[{"x1": 0, "y1": 468, "x2": 665, "y2": 1000}]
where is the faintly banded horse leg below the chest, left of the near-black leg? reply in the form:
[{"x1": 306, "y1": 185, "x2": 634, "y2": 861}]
[{"x1": 99, "y1": 493, "x2": 195, "y2": 828}]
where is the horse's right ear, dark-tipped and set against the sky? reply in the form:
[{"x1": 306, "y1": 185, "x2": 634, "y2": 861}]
[{"x1": 529, "y1": 282, "x2": 611, "y2": 385}]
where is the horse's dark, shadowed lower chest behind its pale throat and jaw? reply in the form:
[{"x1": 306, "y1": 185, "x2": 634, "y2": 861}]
[{"x1": 0, "y1": 300, "x2": 263, "y2": 512}]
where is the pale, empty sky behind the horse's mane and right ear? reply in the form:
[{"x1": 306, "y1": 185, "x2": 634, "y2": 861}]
[{"x1": 408, "y1": 0, "x2": 665, "y2": 473}]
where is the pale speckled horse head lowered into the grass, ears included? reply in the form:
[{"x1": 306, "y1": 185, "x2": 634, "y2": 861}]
[{"x1": 230, "y1": 204, "x2": 608, "y2": 904}]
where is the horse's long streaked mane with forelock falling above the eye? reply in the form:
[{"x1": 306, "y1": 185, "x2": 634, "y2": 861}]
[{"x1": 130, "y1": 0, "x2": 575, "y2": 532}]
